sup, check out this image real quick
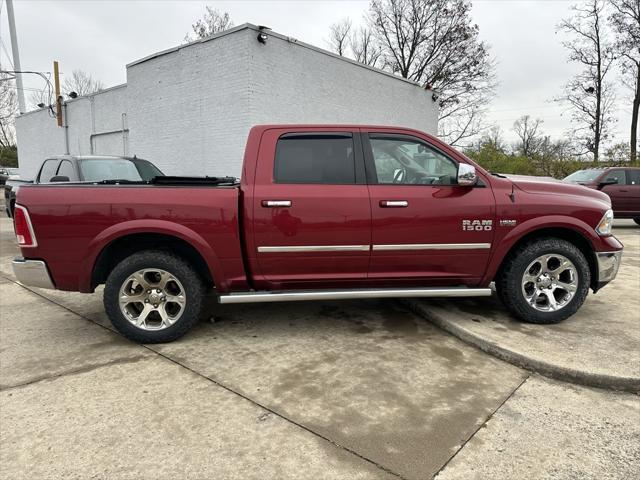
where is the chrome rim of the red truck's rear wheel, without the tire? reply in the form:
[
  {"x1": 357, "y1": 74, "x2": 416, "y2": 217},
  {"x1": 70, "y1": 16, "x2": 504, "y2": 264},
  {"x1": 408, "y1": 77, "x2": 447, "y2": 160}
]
[{"x1": 119, "y1": 268, "x2": 187, "y2": 330}]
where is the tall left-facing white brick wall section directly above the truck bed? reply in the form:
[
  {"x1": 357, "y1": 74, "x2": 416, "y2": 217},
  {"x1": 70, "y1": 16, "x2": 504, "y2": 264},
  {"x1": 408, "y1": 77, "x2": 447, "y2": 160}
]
[{"x1": 127, "y1": 29, "x2": 250, "y2": 176}]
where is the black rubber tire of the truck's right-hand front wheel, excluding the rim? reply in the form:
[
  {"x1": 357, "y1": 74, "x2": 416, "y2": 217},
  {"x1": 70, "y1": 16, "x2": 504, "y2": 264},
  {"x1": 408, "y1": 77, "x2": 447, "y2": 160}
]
[{"x1": 496, "y1": 238, "x2": 591, "y2": 324}]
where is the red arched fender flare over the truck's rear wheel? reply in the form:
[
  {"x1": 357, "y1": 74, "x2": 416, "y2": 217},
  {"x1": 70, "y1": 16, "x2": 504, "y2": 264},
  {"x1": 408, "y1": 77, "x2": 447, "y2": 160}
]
[{"x1": 78, "y1": 219, "x2": 223, "y2": 292}]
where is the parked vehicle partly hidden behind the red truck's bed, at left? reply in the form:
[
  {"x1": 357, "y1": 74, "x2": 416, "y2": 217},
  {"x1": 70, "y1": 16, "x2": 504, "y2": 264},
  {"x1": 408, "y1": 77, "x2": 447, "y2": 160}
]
[{"x1": 4, "y1": 155, "x2": 164, "y2": 218}]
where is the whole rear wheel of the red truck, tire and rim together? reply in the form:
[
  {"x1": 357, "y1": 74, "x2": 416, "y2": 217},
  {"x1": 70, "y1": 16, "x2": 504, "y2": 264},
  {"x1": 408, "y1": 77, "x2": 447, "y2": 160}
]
[{"x1": 104, "y1": 250, "x2": 205, "y2": 343}]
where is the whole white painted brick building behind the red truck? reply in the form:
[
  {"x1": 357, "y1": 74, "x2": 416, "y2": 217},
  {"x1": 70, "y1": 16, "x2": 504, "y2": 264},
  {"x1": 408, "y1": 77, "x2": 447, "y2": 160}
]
[{"x1": 16, "y1": 24, "x2": 437, "y2": 178}]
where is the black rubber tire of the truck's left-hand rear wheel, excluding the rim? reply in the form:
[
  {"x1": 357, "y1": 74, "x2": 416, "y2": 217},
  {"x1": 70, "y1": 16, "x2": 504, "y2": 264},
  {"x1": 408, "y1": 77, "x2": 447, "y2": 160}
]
[{"x1": 103, "y1": 250, "x2": 205, "y2": 343}]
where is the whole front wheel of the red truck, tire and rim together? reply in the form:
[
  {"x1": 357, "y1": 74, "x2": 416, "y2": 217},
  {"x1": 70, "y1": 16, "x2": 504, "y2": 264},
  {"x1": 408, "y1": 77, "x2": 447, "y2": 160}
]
[{"x1": 496, "y1": 238, "x2": 591, "y2": 323}]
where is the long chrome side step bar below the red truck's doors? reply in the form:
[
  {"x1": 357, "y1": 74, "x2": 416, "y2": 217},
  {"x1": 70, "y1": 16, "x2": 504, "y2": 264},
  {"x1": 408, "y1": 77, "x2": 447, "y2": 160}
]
[{"x1": 218, "y1": 287, "x2": 491, "y2": 303}]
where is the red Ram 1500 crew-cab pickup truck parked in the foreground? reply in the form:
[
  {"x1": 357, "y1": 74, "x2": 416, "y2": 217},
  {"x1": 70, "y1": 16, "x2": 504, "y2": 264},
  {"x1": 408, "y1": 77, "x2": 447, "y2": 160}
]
[{"x1": 13, "y1": 125, "x2": 622, "y2": 342}]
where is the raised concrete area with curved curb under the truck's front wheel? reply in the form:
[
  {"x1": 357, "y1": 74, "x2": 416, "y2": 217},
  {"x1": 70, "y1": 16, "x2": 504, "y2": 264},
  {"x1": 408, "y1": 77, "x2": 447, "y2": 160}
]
[{"x1": 408, "y1": 220, "x2": 640, "y2": 392}]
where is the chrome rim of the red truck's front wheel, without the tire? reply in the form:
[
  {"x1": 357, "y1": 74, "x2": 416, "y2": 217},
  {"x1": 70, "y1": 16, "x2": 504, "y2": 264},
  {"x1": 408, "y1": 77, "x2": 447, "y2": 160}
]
[{"x1": 522, "y1": 253, "x2": 578, "y2": 312}]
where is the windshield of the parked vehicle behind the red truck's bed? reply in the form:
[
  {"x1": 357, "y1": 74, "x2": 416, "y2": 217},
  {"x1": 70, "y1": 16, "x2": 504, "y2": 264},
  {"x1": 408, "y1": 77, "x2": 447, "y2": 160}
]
[{"x1": 80, "y1": 158, "x2": 162, "y2": 182}]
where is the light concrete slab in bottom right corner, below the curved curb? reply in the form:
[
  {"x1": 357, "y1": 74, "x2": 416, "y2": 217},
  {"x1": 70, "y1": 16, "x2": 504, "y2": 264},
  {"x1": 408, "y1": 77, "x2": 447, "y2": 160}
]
[{"x1": 436, "y1": 377, "x2": 640, "y2": 480}]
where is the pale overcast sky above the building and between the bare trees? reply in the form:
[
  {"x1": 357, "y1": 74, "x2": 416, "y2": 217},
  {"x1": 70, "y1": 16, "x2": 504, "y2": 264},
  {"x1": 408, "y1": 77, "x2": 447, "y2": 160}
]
[{"x1": 0, "y1": 0, "x2": 631, "y2": 146}]
